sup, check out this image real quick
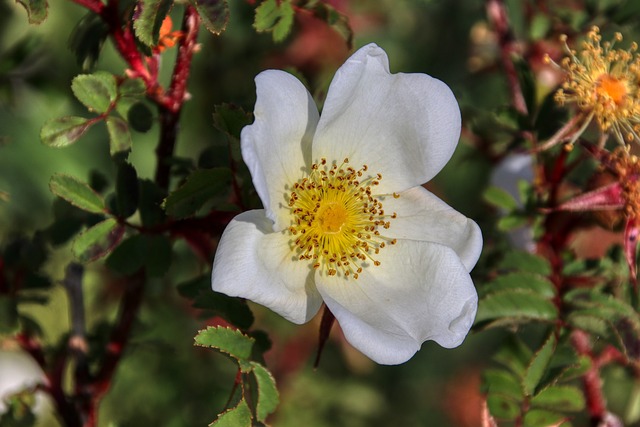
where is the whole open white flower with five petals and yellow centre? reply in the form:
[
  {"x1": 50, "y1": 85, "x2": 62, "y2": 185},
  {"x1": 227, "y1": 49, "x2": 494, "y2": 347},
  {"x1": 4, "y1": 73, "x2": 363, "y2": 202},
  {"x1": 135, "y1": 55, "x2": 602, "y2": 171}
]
[{"x1": 212, "y1": 44, "x2": 482, "y2": 364}]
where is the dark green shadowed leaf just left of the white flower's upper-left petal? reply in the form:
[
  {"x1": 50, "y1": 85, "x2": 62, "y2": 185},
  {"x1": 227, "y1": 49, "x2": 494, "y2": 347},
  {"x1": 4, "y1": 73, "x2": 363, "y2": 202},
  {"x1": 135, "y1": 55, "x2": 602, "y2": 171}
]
[{"x1": 163, "y1": 167, "x2": 231, "y2": 218}]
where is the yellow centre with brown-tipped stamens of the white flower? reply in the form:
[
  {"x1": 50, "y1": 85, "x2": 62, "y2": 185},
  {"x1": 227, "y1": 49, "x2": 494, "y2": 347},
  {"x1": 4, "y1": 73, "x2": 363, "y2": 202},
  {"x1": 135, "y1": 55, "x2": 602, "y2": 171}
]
[{"x1": 289, "y1": 159, "x2": 399, "y2": 279}]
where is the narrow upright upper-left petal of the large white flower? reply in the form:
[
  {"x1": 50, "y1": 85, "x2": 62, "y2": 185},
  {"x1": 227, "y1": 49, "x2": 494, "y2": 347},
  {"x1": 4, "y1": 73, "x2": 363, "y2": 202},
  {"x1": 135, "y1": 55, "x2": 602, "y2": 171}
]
[{"x1": 241, "y1": 70, "x2": 318, "y2": 231}]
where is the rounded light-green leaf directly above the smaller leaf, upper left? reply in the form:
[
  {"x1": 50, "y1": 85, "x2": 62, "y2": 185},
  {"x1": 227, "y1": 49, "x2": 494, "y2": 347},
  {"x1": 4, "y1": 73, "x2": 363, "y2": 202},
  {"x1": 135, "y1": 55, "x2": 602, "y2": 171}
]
[{"x1": 71, "y1": 72, "x2": 118, "y2": 114}]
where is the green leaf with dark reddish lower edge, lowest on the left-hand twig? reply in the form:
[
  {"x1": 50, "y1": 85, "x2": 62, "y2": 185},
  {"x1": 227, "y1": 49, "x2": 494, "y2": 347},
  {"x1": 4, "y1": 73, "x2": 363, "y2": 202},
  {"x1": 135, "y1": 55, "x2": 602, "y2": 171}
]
[{"x1": 72, "y1": 218, "x2": 125, "y2": 262}]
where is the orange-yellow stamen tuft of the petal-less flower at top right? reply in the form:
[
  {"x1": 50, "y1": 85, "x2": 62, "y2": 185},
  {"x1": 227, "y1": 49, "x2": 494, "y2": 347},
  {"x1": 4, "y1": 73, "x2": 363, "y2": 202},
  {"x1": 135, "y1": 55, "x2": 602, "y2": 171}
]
[{"x1": 549, "y1": 26, "x2": 640, "y2": 144}]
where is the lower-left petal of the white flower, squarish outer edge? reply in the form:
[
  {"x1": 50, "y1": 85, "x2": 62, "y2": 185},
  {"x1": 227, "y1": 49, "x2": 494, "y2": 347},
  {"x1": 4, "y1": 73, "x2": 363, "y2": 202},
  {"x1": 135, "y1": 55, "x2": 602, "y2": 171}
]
[{"x1": 211, "y1": 209, "x2": 322, "y2": 324}]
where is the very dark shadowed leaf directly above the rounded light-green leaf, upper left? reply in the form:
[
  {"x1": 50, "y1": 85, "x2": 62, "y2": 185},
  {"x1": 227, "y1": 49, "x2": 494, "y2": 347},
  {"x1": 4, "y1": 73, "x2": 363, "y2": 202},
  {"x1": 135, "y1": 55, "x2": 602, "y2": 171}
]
[{"x1": 69, "y1": 12, "x2": 109, "y2": 72}]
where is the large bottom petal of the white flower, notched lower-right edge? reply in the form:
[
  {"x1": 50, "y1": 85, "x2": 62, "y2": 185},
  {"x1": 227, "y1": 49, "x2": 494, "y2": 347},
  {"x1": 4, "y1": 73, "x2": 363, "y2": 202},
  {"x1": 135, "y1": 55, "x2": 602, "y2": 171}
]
[{"x1": 316, "y1": 240, "x2": 478, "y2": 365}]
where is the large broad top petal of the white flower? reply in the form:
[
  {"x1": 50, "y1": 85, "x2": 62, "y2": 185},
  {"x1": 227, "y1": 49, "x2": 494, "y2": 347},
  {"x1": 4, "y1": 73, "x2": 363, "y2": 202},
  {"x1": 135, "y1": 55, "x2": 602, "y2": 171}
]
[{"x1": 313, "y1": 44, "x2": 460, "y2": 193}]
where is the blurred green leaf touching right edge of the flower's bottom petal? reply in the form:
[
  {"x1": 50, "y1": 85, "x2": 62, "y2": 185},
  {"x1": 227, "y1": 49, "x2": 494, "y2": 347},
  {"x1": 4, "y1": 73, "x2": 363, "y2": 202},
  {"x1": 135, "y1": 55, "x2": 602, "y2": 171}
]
[{"x1": 476, "y1": 289, "x2": 558, "y2": 323}]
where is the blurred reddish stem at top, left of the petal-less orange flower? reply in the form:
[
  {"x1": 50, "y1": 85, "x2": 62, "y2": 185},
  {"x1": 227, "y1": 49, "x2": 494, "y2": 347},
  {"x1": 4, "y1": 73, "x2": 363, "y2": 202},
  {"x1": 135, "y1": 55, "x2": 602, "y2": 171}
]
[{"x1": 486, "y1": 0, "x2": 528, "y2": 115}]
